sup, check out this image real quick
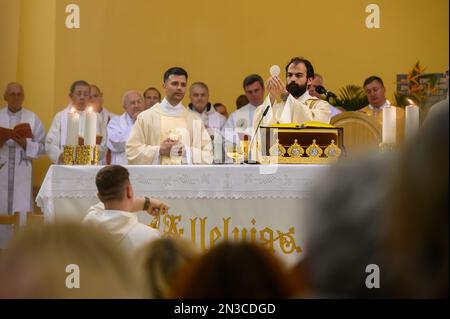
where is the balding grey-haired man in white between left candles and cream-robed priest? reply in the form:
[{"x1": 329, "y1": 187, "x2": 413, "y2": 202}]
[{"x1": 107, "y1": 91, "x2": 145, "y2": 165}]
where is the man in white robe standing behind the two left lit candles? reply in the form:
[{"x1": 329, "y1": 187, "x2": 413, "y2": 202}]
[{"x1": 45, "y1": 81, "x2": 106, "y2": 164}]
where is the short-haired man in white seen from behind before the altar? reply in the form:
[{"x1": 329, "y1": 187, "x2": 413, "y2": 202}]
[{"x1": 83, "y1": 165, "x2": 161, "y2": 252}]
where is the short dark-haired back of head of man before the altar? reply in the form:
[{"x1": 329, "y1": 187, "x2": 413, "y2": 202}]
[{"x1": 95, "y1": 165, "x2": 130, "y2": 202}]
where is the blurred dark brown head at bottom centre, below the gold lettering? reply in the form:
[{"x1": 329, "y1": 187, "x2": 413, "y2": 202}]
[{"x1": 174, "y1": 242, "x2": 292, "y2": 299}]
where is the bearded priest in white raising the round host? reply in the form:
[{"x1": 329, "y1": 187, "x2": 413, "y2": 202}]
[{"x1": 253, "y1": 57, "x2": 331, "y2": 130}]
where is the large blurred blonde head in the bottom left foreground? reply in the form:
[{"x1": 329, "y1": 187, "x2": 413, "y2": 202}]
[{"x1": 0, "y1": 223, "x2": 143, "y2": 298}]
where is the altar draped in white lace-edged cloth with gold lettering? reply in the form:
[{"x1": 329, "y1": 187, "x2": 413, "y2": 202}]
[{"x1": 36, "y1": 165, "x2": 329, "y2": 265}]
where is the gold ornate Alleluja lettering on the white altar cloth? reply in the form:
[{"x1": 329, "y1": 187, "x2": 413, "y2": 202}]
[{"x1": 152, "y1": 214, "x2": 302, "y2": 255}]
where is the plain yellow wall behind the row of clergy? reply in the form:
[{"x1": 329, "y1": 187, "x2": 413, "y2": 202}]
[{"x1": 0, "y1": 0, "x2": 449, "y2": 189}]
